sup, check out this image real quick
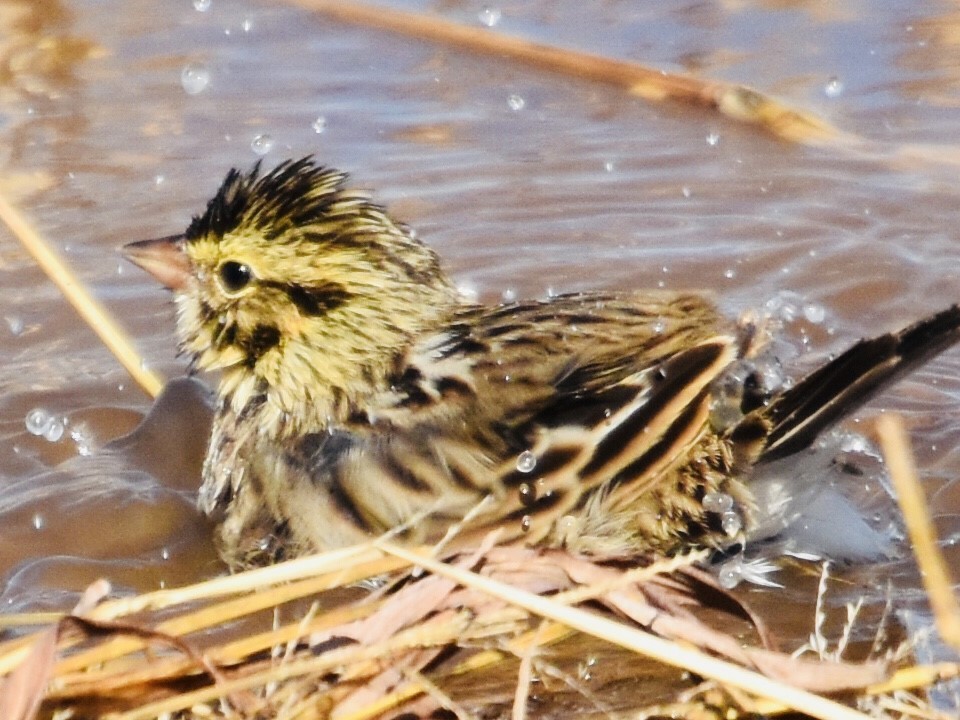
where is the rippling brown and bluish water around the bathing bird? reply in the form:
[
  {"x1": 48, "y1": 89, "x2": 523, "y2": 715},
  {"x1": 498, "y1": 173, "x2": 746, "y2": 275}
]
[{"x1": 0, "y1": 0, "x2": 960, "y2": 668}]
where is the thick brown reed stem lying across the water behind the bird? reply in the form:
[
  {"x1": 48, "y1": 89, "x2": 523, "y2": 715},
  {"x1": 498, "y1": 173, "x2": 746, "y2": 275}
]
[{"x1": 288, "y1": 0, "x2": 840, "y2": 146}]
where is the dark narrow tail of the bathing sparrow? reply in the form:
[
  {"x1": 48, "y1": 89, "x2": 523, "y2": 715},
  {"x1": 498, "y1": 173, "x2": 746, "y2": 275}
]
[{"x1": 734, "y1": 305, "x2": 960, "y2": 462}]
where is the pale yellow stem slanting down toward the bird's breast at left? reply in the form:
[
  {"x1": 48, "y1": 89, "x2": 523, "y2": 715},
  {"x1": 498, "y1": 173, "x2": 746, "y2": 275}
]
[{"x1": 0, "y1": 188, "x2": 164, "y2": 397}]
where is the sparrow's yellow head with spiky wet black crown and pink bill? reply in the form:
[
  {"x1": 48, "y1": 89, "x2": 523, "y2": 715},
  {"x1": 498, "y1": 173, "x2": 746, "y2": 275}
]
[{"x1": 124, "y1": 157, "x2": 457, "y2": 431}]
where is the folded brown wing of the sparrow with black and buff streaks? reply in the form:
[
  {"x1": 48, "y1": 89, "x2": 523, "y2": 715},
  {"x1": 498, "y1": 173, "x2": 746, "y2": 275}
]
[{"x1": 338, "y1": 295, "x2": 738, "y2": 541}]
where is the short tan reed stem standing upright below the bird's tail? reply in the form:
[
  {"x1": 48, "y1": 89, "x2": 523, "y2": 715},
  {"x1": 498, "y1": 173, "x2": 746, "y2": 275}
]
[{"x1": 877, "y1": 414, "x2": 960, "y2": 650}]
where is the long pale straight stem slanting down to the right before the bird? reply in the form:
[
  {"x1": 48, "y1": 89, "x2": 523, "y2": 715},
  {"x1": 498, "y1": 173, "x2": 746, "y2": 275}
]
[{"x1": 376, "y1": 542, "x2": 869, "y2": 720}]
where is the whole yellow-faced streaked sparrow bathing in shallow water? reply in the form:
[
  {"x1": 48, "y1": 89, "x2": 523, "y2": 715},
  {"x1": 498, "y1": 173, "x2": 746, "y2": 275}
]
[{"x1": 125, "y1": 158, "x2": 960, "y2": 566}]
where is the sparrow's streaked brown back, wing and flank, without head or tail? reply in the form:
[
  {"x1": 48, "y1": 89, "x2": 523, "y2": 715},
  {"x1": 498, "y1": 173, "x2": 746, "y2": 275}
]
[{"x1": 210, "y1": 293, "x2": 748, "y2": 554}]
